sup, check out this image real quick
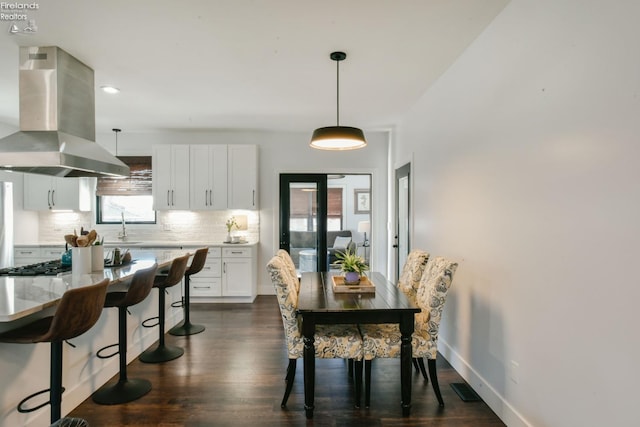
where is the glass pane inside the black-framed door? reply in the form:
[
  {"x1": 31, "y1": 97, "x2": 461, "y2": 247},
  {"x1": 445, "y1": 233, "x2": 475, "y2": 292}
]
[{"x1": 289, "y1": 182, "x2": 318, "y2": 273}]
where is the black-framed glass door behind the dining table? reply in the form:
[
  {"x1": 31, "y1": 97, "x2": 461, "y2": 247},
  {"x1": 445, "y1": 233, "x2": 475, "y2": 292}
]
[{"x1": 280, "y1": 174, "x2": 328, "y2": 271}]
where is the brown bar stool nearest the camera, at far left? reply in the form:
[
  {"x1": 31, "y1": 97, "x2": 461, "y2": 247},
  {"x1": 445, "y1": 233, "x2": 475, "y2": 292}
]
[{"x1": 0, "y1": 279, "x2": 109, "y2": 424}]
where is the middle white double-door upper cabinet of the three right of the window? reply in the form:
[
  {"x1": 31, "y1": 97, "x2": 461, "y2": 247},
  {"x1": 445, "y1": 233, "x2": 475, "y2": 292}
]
[{"x1": 190, "y1": 145, "x2": 227, "y2": 210}]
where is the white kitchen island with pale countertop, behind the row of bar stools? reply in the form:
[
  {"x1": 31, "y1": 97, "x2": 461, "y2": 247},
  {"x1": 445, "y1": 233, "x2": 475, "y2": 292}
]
[{"x1": 0, "y1": 249, "x2": 191, "y2": 426}]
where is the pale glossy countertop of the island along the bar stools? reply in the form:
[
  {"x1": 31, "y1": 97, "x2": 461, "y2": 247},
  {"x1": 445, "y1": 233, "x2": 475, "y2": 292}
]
[{"x1": 0, "y1": 249, "x2": 187, "y2": 322}]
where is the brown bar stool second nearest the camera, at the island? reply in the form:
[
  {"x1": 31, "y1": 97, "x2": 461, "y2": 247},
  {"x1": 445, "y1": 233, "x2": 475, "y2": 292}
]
[{"x1": 91, "y1": 264, "x2": 158, "y2": 405}]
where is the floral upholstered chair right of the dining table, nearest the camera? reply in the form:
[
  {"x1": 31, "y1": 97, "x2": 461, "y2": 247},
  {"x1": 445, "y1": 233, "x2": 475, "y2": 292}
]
[{"x1": 360, "y1": 257, "x2": 458, "y2": 406}]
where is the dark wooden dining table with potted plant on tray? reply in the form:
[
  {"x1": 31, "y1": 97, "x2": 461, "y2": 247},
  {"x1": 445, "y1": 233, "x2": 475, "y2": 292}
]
[{"x1": 297, "y1": 272, "x2": 420, "y2": 419}]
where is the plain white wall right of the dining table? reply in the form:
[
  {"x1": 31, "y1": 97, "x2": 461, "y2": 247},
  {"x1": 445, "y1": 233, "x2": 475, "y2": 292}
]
[{"x1": 393, "y1": 0, "x2": 640, "y2": 427}]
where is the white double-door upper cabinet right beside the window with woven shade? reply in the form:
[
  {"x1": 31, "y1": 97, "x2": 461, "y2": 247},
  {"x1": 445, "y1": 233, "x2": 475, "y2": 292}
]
[{"x1": 152, "y1": 145, "x2": 189, "y2": 210}]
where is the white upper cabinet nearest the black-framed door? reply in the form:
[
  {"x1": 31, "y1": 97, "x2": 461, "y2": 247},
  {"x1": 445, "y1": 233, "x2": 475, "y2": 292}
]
[{"x1": 227, "y1": 145, "x2": 258, "y2": 209}]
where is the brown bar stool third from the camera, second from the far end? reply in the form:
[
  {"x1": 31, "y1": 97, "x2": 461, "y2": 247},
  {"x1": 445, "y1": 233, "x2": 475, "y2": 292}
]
[{"x1": 139, "y1": 254, "x2": 189, "y2": 363}]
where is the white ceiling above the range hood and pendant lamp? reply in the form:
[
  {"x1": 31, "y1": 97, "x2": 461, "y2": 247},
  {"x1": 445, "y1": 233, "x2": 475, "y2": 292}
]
[{"x1": 0, "y1": 0, "x2": 508, "y2": 132}]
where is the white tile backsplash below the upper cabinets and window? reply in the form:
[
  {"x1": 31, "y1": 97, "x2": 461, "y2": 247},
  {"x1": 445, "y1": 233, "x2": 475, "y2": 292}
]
[{"x1": 33, "y1": 210, "x2": 260, "y2": 244}]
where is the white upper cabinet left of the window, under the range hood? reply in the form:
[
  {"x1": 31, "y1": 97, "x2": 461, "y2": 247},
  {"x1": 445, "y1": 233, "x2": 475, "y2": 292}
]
[{"x1": 23, "y1": 173, "x2": 91, "y2": 211}]
